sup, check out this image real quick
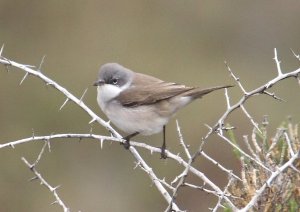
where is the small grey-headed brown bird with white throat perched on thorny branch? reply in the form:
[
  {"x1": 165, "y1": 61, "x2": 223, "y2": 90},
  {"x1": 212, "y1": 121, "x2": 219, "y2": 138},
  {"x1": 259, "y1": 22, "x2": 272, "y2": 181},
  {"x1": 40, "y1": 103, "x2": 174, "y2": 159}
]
[{"x1": 94, "y1": 63, "x2": 232, "y2": 159}]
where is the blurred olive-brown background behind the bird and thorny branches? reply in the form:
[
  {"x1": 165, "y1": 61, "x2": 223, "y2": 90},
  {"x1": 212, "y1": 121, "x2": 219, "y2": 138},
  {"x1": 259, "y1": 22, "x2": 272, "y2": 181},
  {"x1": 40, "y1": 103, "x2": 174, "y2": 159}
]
[{"x1": 0, "y1": 0, "x2": 300, "y2": 212}]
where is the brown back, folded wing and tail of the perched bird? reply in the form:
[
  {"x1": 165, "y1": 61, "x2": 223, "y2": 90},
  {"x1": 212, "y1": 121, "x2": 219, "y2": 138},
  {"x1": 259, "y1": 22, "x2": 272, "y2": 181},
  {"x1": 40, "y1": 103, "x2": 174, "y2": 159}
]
[{"x1": 116, "y1": 73, "x2": 232, "y2": 107}]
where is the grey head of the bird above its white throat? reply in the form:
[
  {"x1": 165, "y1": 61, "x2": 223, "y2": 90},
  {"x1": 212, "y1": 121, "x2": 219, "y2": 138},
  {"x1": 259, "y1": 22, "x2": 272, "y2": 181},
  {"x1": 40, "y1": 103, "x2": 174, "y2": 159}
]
[{"x1": 94, "y1": 63, "x2": 133, "y2": 87}]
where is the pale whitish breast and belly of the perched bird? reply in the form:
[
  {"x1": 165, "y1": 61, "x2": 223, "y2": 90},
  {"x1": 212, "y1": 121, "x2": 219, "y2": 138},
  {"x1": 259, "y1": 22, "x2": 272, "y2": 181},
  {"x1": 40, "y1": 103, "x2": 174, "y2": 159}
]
[{"x1": 102, "y1": 102, "x2": 169, "y2": 135}]
